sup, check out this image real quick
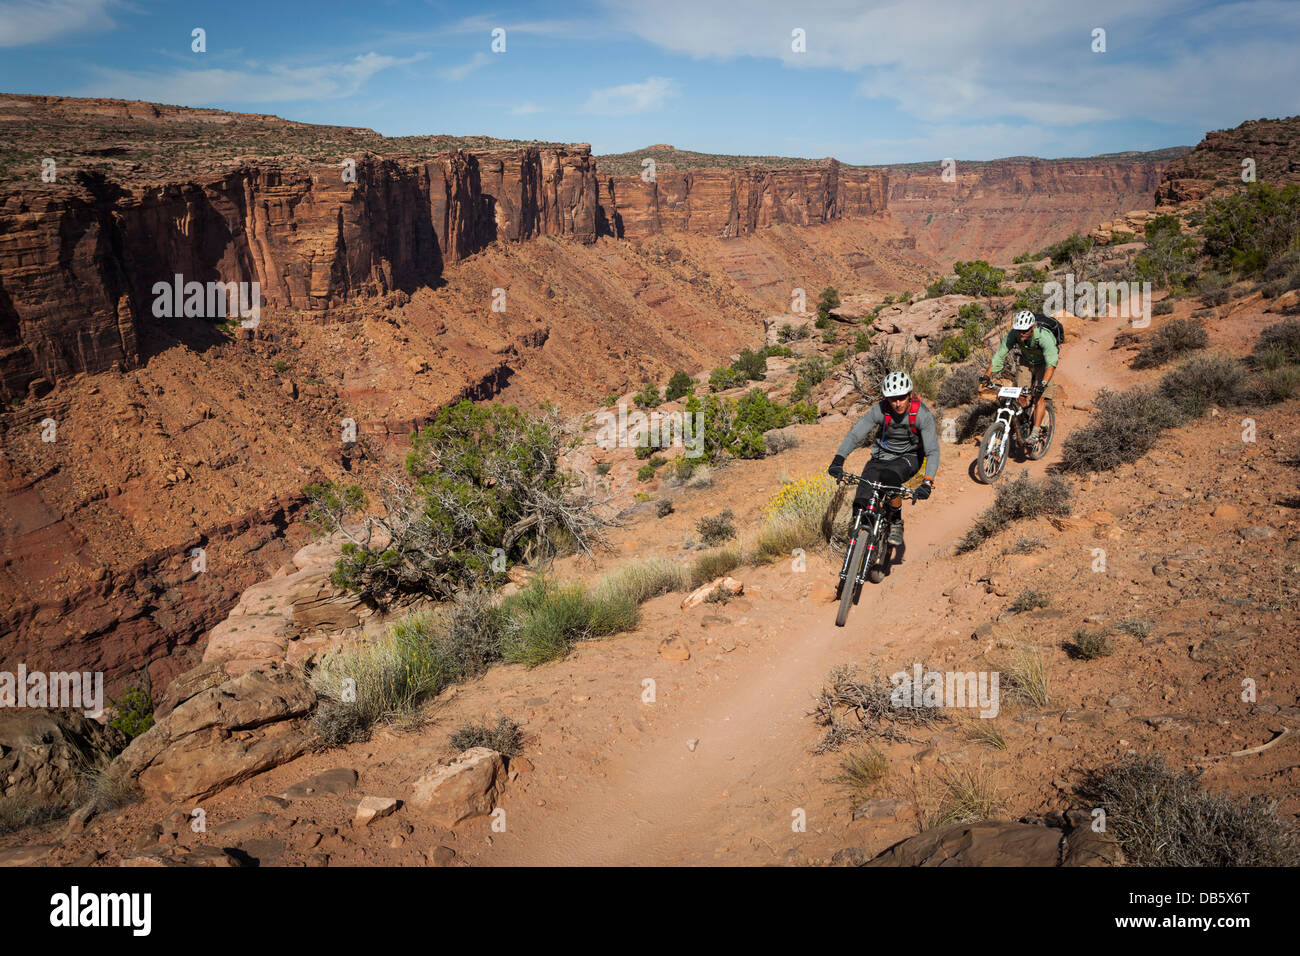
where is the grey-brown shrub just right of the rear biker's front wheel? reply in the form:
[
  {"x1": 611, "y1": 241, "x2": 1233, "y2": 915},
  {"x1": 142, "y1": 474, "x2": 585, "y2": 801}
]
[{"x1": 1061, "y1": 385, "x2": 1183, "y2": 472}]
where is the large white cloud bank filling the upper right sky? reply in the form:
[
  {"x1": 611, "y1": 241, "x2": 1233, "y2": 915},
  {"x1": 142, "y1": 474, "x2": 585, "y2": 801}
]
[{"x1": 602, "y1": 0, "x2": 1300, "y2": 127}]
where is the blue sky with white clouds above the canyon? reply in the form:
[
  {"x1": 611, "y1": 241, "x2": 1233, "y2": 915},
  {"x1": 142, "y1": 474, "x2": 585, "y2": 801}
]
[{"x1": 0, "y1": 0, "x2": 1300, "y2": 163}]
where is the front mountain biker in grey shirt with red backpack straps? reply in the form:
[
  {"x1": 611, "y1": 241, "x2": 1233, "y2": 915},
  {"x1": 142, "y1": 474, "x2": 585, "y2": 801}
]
[{"x1": 827, "y1": 372, "x2": 939, "y2": 545}]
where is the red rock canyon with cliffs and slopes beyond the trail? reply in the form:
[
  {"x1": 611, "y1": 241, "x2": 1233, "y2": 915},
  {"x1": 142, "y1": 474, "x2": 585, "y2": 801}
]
[{"x1": 0, "y1": 96, "x2": 1185, "y2": 692}]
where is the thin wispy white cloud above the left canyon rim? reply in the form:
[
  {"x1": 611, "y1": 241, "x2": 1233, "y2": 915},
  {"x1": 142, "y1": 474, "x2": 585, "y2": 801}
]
[{"x1": 79, "y1": 53, "x2": 423, "y2": 107}]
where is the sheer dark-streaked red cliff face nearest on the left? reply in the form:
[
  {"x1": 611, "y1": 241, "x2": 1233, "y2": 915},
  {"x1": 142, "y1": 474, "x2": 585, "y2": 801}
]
[{"x1": 0, "y1": 146, "x2": 597, "y2": 399}]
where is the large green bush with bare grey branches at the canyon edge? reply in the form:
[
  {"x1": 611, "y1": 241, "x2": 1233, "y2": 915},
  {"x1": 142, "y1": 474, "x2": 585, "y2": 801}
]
[{"x1": 303, "y1": 401, "x2": 610, "y2": 605}]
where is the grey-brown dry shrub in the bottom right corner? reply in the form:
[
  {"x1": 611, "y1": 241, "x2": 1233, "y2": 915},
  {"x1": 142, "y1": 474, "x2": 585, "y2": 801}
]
[{"x1": 1079, "y1": 754, "x2": 1300, "y2": 868}]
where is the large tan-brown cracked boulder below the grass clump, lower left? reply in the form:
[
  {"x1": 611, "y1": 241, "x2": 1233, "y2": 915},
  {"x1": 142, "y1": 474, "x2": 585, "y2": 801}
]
[{"x1": 113, "y1": 669, "x2": 316, "y2": 800}]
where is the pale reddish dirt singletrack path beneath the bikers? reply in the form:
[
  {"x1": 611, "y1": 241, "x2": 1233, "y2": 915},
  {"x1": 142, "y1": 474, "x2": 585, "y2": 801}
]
[{"x1": 475, "y1": 319, "x2": 1134, "y2": 865}]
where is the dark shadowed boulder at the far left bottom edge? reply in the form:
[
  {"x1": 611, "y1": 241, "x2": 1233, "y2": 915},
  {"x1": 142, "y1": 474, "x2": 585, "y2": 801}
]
[{"x1": 0, "y1": 708, "x2": 127, "y2": 806}]
